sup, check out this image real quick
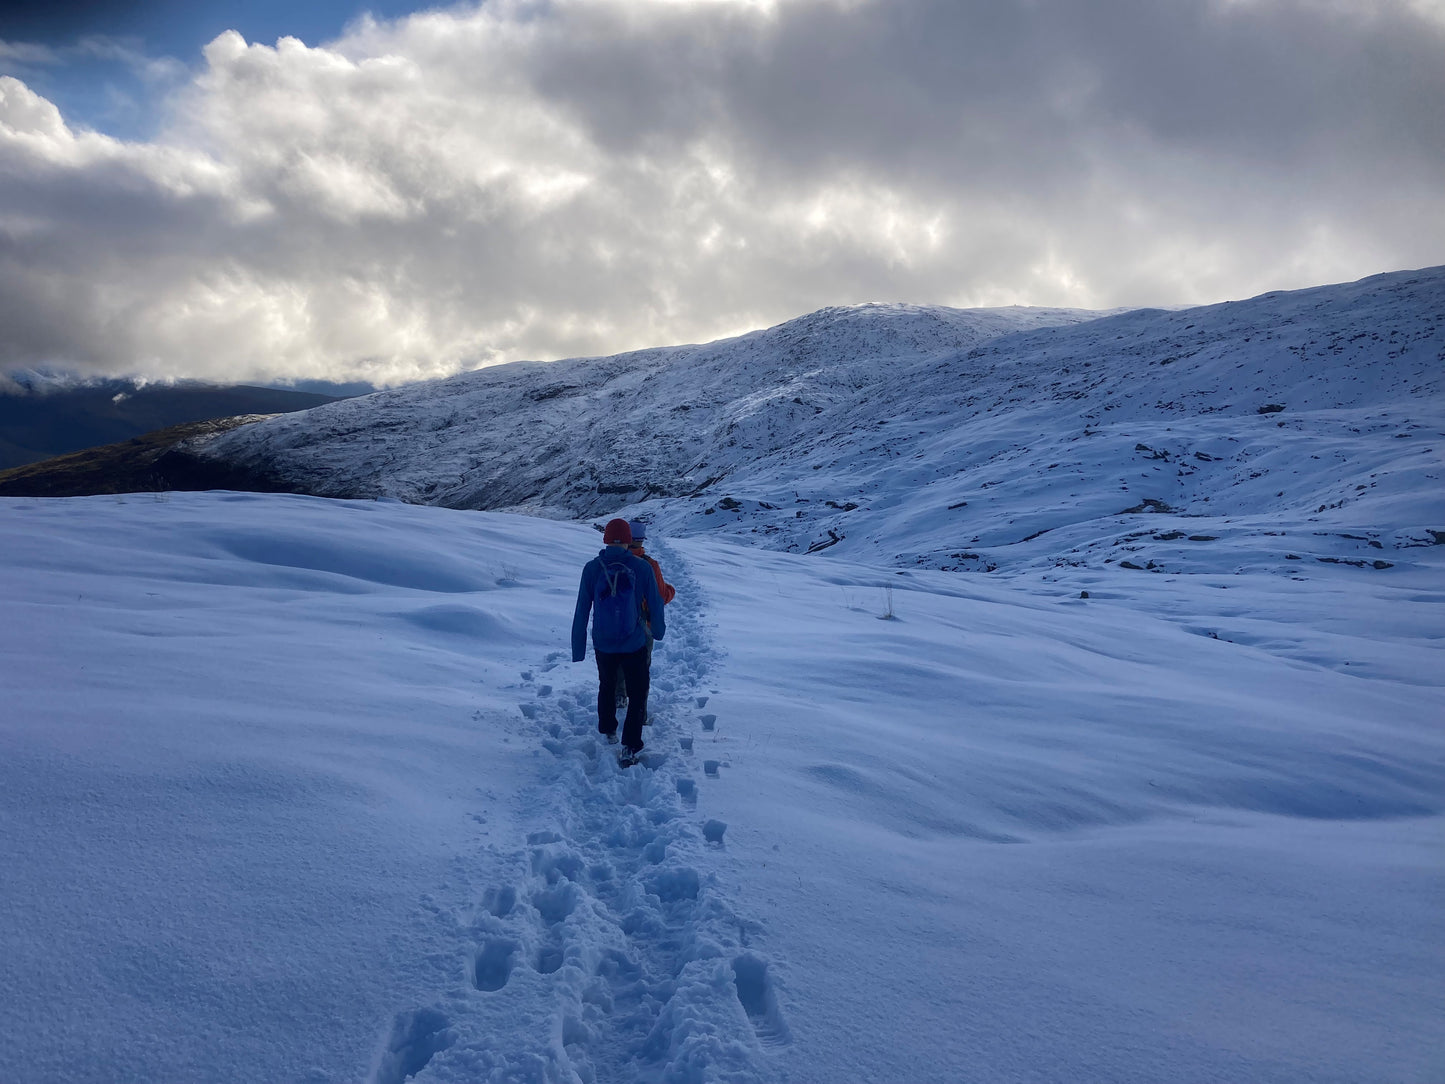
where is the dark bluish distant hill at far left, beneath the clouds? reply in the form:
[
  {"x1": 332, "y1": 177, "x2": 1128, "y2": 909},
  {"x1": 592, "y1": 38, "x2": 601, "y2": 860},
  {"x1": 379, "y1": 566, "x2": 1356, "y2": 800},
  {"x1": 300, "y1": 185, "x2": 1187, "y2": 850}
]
[{"x1": 0, "y1": 380, "x2": 344, "y2": 470}]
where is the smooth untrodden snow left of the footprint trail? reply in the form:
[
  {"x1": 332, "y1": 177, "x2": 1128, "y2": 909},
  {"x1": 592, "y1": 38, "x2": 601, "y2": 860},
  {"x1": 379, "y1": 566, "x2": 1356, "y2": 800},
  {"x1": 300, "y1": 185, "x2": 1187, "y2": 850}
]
[{"x1": 0, "y1": 494, "x2": 553, "y2": 1083}]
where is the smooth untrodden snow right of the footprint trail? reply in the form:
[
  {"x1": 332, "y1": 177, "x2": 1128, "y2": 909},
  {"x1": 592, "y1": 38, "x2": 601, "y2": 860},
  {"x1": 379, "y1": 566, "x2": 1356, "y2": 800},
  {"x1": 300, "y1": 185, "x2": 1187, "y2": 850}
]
[{"x1": 670, "y1": 539, "x2": 1445, "y2": 1083}]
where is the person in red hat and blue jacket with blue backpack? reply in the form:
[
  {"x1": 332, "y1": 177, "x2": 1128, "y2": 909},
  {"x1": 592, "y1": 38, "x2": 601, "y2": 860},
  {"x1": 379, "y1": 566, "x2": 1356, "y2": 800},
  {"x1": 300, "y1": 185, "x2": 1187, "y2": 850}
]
[{"x1": 572, "y1": 519, "x2": 668, "y2": 757}]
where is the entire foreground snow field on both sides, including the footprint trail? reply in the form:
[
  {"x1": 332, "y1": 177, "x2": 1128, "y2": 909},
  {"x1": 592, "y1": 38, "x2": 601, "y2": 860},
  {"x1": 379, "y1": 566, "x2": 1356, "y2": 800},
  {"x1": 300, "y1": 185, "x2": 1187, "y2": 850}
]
[{"x1": 0, "y1": 493, "x2": 1445, "y2": 1084}]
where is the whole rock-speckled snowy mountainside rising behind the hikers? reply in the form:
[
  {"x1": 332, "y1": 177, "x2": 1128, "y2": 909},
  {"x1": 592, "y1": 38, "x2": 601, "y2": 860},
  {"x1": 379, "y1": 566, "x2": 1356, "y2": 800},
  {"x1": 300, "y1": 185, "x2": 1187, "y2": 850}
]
[{"x1": 204, "y1": 267, "x2": 1445, "y2": 572}]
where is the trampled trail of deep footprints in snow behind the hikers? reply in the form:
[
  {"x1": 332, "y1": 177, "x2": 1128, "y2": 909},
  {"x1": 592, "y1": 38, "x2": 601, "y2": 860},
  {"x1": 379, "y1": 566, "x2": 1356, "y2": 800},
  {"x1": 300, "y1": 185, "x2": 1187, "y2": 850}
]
[{"x1": 384, "y1": 558, "x2": 792, "y2": 1084}]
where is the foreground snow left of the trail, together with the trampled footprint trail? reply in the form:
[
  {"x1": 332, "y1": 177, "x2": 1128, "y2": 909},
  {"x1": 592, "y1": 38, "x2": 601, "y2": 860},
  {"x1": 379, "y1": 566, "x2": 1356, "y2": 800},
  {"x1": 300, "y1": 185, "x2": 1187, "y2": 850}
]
[{"x1": 0, "y1": 493, "x2": 786, "y2": 1084}]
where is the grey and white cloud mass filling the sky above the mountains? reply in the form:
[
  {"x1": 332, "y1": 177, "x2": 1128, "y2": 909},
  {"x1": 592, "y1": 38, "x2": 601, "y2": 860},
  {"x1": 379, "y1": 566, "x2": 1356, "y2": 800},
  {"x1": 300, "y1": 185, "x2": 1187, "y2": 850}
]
[{"x1": 0, "y1": 0, "x2": 1445, "y2": 382}]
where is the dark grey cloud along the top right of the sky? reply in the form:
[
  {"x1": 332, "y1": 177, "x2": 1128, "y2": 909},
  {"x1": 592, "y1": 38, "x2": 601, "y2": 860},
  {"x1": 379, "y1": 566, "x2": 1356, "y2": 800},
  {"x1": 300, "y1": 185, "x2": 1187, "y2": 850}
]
[{"x1": 532, "y1": 0, "x2": 1445, "y2": 192}]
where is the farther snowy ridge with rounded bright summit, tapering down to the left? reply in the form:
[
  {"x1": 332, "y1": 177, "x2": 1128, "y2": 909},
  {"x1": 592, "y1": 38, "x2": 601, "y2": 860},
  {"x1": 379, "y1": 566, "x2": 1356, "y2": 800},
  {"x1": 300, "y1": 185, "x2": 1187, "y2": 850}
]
[{"x1": 207, "y1": 305, "x2": 1097, "y2": 517}]
